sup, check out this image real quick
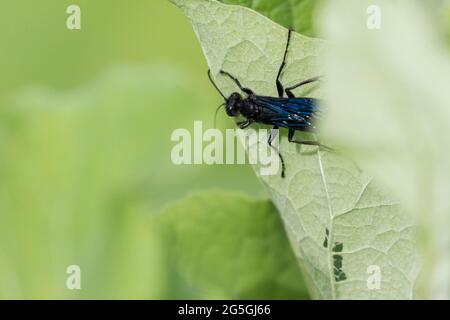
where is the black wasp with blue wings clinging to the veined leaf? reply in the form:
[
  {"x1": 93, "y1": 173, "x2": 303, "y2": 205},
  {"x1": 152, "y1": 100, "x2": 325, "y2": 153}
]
[{"x1": 208, "y1": 30, "x2": 326, "y2": 178}]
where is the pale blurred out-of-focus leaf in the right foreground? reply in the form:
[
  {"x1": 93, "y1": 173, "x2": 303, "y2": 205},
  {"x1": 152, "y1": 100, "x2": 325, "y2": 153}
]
[{"x1": 322, "y1": 0, "x2": 450, "y2": 299}]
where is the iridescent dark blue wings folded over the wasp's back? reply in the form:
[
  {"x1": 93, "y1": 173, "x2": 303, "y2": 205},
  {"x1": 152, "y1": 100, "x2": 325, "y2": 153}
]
[{"x1": 253, "y1": 96, "x2": 320, "y2": 131}]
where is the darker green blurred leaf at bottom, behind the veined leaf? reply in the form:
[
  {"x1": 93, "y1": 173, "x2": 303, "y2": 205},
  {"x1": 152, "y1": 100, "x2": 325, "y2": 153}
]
[{"x1": 151, "y1": 191, "x2": 308, "y2": 299}]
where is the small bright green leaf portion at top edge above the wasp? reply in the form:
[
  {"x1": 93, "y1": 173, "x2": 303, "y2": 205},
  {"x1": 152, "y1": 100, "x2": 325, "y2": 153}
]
[{"x1": 222, "y1": 0, "x2": 323, "y2": 37}]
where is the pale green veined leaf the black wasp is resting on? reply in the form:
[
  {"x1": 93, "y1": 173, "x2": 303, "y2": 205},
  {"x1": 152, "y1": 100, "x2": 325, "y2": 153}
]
[{"x1": 172, "y1": 0, "x2": 418, "y2": 299}]
